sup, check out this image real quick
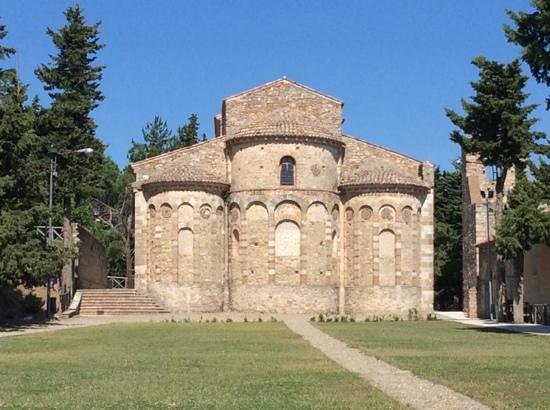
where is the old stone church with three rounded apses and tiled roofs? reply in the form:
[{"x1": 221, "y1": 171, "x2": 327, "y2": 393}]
[{"x1": 132, "y1": 78, "x2": 434, "y2": 316}]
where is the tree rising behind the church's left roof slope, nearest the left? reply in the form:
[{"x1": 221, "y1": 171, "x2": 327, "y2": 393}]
[{"x1": 128, "y1": 115, "x2": 173, "y2": 162}]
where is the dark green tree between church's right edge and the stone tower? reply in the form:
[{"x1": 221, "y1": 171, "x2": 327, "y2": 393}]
[{"x1": 434, "y1": 168, "x2": 462, "y2": 310}]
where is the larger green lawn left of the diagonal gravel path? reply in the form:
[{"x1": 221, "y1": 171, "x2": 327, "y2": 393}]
[{"x1": 0, "y1": 323, "x2": 399, "y2": 409}]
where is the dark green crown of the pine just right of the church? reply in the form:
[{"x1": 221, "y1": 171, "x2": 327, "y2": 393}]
[{"x1": 445, "y1": 57, "x2": 544, "y2": 196}]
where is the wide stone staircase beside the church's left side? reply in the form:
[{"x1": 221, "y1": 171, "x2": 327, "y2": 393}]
[{"x1": 79, "y1": 289, "x2": 170, "y2": 316}]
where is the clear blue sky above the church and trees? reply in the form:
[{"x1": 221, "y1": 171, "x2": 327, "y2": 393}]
[{"x1": 0, "y1": 0, "x2": 550, "y2": 168}]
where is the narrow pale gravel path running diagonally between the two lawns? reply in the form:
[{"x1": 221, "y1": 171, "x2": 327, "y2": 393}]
[{"x1": 282, "y1": 316, "x2": 489, "y2": 410}]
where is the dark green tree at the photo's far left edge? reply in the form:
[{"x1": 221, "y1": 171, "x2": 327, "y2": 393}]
[{"x1": 0, "y1": 26, "x2": 66, "y2": 290}]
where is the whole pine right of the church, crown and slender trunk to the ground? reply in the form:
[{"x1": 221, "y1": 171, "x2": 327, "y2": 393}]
[{"x1": 446, "y1": 57, "x2": 545, "y2": 323}]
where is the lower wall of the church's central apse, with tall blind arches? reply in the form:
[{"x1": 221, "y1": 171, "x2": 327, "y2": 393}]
[{"x1": 229, "y1": 190, "x2": 339, "y2": 312}]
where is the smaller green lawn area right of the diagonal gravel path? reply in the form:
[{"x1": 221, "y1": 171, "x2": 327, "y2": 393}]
[{"x1": 317, "y1": 321, "x2": 550, "y2": 409}]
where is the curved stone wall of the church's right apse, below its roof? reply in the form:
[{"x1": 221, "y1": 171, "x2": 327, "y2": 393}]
[{"x1": 344, "y1": 192, "x2": 433, "y2": 314}]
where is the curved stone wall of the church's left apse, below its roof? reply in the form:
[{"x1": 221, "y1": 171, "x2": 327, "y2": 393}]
[{"x1": 140, "y1": 191, "x2": 225, "y2": 311}]
